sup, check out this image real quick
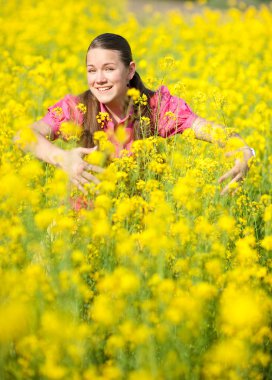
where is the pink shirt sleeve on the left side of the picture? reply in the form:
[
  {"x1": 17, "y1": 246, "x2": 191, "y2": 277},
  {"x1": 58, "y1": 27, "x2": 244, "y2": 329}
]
[{"x1": 41, "y1": 95, "x2": 83, "y2": 139}]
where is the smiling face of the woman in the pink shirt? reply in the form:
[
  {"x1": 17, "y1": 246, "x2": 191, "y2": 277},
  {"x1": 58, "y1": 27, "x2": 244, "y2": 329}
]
[{"x1": 87, "y1": 48, "x2": 135, "y2": 112}]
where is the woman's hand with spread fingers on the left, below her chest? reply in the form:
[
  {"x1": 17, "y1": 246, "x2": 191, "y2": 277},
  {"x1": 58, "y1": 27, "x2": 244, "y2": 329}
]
[{"x1": 59, "y1": 147, "x2": 103, "y2": 194}]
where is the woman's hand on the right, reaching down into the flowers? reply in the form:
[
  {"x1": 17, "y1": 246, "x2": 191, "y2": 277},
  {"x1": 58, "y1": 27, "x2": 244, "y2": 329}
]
[{"x1": 218, "y1": 147, "x2": 255, "y2": 195}]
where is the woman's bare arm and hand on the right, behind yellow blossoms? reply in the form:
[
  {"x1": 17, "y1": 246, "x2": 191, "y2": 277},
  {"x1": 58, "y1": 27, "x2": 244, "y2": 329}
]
[{"x1": 191, "y1": 117, "x2": 255, "y2": 195}]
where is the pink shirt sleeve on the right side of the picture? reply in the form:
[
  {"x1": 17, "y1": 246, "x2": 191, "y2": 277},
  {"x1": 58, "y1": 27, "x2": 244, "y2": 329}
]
[{"x1": 150, "y1": 86, "x2": 197, "y2": 137}]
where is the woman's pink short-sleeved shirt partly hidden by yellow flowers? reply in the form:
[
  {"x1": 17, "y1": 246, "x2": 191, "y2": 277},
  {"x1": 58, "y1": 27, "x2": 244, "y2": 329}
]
[{"x1": 41, "y1": 86, "x2": 197, "y2": 156}]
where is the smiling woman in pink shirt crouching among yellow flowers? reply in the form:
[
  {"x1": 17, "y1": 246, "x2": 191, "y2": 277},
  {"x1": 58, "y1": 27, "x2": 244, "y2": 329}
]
[{"x1": 23, "y1": 33, "x2": 254, "y2": 194}]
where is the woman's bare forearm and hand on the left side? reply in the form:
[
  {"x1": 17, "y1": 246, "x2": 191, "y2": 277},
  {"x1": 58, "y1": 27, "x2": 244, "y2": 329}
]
[{"x1": 15, "y1": 120, "x2": 103, "y2": 193}]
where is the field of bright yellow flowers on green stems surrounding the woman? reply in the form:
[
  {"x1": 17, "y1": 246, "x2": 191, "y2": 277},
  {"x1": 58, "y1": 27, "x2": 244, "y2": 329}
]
[{"x1": 0, "y1": 0, "x2": 272, "y2": 380}]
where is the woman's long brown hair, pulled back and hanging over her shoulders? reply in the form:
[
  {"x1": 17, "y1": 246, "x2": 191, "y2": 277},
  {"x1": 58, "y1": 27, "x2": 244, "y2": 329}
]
[{"x1": 78, "y1": 33, "x2": 154, "y2": 148}]
